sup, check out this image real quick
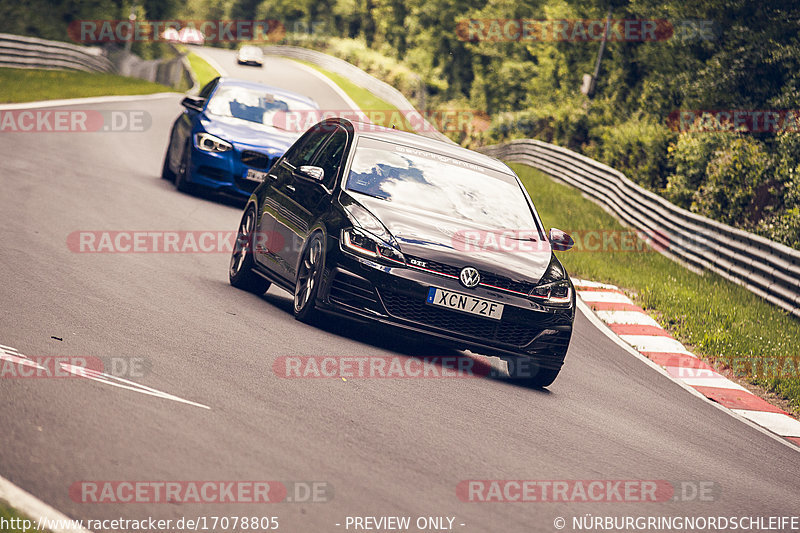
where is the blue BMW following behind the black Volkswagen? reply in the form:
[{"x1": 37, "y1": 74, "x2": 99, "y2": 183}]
[{"x1": 161, "y1": 78, "x2": 319, "y2": 198}]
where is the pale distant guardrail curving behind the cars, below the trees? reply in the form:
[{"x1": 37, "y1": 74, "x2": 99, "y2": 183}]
[{"x1": 263, "y1": 45, "x2": 453, "y2": 143}]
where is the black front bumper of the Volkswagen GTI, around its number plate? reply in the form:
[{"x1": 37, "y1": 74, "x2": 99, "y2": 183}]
[{"x1": 317, "y1": 250, "x2": 575, "y2": 369}]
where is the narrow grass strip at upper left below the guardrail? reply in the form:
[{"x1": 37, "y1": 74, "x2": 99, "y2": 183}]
[{"x1": 0, "y1": 68, "x2": 173, "y2": 104}]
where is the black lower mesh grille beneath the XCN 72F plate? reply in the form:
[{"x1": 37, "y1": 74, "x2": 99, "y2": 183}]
[{"x1": 380, "y1": 289, "x2": 548, "y2": 348}]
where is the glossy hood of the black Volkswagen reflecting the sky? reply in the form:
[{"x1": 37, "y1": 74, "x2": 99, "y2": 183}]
[{"x1": 357, "y1": 195, "x2": 552, "y2": 283}]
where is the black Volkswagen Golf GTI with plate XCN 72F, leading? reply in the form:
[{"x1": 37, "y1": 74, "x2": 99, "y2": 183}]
[{"x1": 229, "y1": 118, "x2": 575, "y2": 387}]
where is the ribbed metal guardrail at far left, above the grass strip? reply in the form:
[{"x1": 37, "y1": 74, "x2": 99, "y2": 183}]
[{"x1": 0, "y1": 33, "x2": 116, "y2": 72}]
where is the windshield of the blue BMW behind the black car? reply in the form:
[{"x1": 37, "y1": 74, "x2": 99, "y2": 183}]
[{"x1": 206, "y1": 86, "x2": 314, "y2": 126}]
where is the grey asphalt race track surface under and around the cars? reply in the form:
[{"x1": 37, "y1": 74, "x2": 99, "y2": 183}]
[{"x1": 0, "y1": 47, "x2": 800, "y2": 533}]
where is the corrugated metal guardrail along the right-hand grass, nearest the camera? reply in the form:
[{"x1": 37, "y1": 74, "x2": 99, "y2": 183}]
[{"x1": 479, "y1": 139, "x2": 800, "y2": 317}]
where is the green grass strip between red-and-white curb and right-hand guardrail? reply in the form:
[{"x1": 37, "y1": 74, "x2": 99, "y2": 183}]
[{"x1": 510, "y1": 163, "x2": 800, "y2": 414}]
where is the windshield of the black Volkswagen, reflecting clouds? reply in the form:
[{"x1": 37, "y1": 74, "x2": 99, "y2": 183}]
[{"x1": 347, "y1": 137, "x2": 537, "y2": 231}]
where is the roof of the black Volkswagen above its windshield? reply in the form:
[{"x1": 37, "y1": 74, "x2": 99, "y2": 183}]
[{"x1": 329, "y1": 118, "x2": 515, "y2": 176}]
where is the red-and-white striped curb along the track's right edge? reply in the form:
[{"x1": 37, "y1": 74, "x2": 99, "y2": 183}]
[{"x1": 572, "y1": 279, "x2": 800, "y2": 446}]
